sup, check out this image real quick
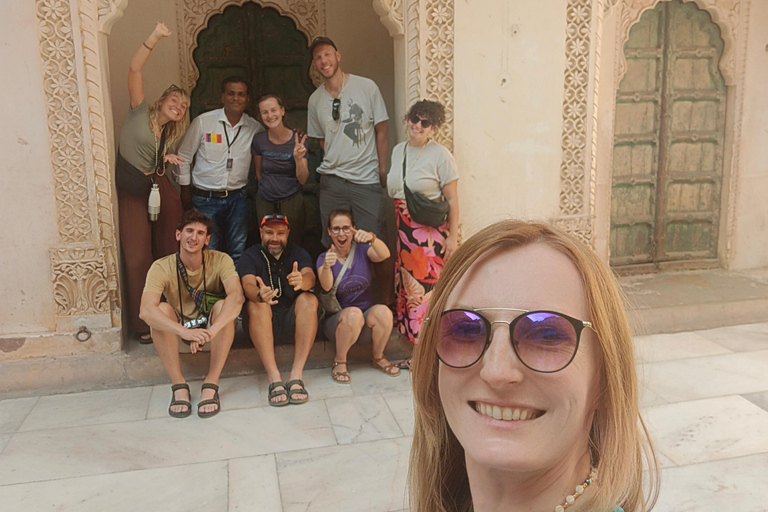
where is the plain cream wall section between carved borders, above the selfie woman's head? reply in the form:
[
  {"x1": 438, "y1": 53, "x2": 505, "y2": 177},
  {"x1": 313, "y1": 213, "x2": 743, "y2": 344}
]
[{"x1": 454, "y1": 0, "x2": 566, "y2": 237}]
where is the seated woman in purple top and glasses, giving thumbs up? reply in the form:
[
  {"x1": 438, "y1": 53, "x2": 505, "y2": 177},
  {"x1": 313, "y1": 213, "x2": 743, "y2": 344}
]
[{"x1": 317, "y1": 210, "x2": 400, "y2": 384}]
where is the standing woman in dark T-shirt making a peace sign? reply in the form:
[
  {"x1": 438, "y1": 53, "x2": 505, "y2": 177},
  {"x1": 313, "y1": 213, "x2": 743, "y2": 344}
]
[{"x1": 251, "y1": 93, "x2": 309, "y2": 246}]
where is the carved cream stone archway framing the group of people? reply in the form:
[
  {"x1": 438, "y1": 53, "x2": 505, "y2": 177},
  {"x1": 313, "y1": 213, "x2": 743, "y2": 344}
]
[{"x1": 28, "y1": 0, "x2": 453, "y2": 355}]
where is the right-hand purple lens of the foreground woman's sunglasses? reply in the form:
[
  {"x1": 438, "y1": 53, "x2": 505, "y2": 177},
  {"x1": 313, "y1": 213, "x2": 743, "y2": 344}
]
[{"x1": 512, "y1": 312, "x2": 578, "y2": 372}]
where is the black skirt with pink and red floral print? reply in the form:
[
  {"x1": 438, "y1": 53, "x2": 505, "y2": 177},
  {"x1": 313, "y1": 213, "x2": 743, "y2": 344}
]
[{"x1": 395, "y1": 199, "x2": 448, "y2": 343}]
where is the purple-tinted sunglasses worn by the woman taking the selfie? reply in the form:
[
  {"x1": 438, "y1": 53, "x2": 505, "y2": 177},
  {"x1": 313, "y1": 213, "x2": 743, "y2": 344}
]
[{"x1": 437, "y1": 308, "x2": 592, "y2": 373}]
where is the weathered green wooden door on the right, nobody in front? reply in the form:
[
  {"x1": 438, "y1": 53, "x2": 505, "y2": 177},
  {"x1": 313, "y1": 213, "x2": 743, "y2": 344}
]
[{"x1": 610, "y1": 0, "x2": 726, "y2": 270}]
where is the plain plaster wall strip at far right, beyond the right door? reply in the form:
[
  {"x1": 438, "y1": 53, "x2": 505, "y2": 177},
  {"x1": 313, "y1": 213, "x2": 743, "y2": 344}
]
[{"x1": 728, "y1": 1, "x2": 768, "y2": 270}]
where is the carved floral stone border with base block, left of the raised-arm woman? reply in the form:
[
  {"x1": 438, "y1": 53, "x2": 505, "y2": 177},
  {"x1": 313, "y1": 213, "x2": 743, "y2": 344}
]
[{"x1": 35, "y1": 0, "x2": 122, "y2": 325}]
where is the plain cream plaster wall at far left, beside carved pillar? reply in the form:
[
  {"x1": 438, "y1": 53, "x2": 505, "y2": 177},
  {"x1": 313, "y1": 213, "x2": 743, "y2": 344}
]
[{"x1": 0, "y1": 1, "x2": 58, "y2": 335}]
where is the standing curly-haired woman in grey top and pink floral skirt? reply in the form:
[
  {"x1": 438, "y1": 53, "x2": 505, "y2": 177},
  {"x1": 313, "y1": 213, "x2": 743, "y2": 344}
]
[{"x1": 387, "y1": 100, "x2": 459, "y2": 369}]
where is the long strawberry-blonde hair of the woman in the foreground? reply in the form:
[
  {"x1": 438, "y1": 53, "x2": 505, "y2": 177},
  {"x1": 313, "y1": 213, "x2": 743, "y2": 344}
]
[{"x1": 409, "y1": 220, "x2": 659, "y2": 512}]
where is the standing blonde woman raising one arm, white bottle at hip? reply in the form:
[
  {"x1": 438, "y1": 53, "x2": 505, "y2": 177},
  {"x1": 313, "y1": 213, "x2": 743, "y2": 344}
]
[{"x1": 120, "y1": 23, "x2": 189, "y2": 343}]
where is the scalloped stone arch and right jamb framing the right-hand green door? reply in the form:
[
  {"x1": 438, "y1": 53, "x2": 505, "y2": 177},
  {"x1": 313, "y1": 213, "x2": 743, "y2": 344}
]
[{"x1": 605, "y1": 0, "x2": 750, "y2": 263}]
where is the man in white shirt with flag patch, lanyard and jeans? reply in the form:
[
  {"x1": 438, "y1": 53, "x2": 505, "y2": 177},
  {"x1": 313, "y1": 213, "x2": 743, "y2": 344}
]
[{"x1": 178, "y1": 76, "x2": 264, "y2": 264}]
